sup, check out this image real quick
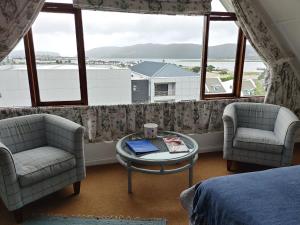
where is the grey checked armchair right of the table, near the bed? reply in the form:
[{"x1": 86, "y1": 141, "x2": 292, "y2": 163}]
[{"x1": 223, "y1": 103, "x2": 300, "y2": 170}]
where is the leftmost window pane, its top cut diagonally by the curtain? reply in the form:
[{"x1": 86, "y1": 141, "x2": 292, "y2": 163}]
[{"x1": 0, "y1": 39, "x2": 31, "y2": 107}]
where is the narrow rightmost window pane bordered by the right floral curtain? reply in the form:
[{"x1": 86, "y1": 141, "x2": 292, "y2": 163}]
[{"x1": 241, "y1": 41, "x2": 266, "y2": 97}]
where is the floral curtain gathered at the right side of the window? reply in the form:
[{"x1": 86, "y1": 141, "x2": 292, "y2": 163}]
[{"x1": 231, "y1": 0, "x2": 300, "y2": 116}]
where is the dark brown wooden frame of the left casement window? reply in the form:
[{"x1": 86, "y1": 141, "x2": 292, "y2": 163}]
[{"x1": 24, "y1": 2, "x2": 88, "y2": 106}]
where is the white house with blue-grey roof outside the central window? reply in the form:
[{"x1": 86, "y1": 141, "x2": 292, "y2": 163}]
[{"x1": 130, "y1": 61, "x2": 200, "y2": 102}]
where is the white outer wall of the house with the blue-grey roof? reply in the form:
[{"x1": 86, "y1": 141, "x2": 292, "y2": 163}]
[{"x1": 150, "y1": 76, "x2": 200, "y2": 102}]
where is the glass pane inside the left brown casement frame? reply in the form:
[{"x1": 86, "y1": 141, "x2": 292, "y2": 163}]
[{"x1": 32, "y1": 13, "x2": 81, "y2": 102}]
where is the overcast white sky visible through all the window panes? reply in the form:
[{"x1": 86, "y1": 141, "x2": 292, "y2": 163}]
[{"x1": 16, "y1": 0, "x2": 238, "y2": 56}]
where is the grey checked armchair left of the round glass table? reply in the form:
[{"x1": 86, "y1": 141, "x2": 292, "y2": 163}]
[{"x1": 0, "y1": 114, "x2": 86, "y2": 222}]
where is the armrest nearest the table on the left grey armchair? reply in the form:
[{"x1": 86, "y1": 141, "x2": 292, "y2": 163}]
[{"x1": 45, "y1": 114, "x2": 84, "y2": 158}]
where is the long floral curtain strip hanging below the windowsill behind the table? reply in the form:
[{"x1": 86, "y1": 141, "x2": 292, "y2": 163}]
[{"x1": 0, "y1": 97, "x2": 263, "y2": 142}]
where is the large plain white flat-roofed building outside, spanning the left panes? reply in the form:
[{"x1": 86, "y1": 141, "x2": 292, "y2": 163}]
[{"x1": 0, "y1": 65, "x2": 131, "y2": 107}]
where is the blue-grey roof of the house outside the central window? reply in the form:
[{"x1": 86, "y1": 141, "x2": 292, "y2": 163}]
[{"x1": 131, "y1": 61, "x2": 199, "y2": 77}]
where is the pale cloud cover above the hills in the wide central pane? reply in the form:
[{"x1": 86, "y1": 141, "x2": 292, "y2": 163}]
[{"x1": 83, "y1": 11, "x2": 203, "y2": 47}]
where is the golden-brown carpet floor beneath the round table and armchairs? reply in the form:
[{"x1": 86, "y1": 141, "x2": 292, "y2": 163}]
[{"x1": 0, "y1": 145, "x2": 300, "y2": 225}]
